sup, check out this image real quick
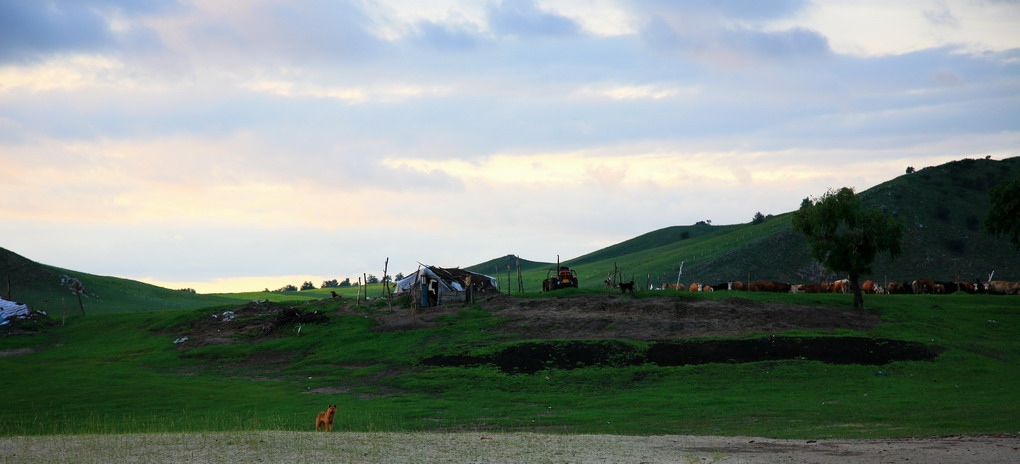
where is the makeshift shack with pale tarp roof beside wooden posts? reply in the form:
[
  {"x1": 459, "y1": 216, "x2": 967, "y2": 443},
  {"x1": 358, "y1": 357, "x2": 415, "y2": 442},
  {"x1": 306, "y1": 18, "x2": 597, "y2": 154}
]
[{"x1": 394, "y1": 266, "x2": 500, "y2": 307}]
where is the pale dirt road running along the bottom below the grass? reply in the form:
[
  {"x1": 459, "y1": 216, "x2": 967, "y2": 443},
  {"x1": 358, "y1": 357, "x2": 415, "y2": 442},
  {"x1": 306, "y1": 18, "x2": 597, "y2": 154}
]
[{"x1": 0, "y1": 431, "x2": 1020, "y2": 464}]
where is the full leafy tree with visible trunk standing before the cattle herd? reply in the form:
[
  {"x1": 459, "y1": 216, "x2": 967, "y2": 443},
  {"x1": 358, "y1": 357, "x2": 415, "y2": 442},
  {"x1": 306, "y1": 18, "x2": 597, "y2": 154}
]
[{"x1": 793, "y1": 187, "x2": 904, "y2": 308}]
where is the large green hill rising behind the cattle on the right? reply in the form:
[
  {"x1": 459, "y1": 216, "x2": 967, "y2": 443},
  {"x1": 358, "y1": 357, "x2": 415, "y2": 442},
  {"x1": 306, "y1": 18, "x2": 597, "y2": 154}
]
[{"x1": 470, "y1": 157, "x2": 1020, "y2": 291}]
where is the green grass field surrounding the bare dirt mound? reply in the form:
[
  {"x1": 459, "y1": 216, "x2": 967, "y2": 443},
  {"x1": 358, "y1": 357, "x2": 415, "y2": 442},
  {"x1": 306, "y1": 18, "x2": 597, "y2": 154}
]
[{"x1": 0, "y1": 291, "x2": 1020, "y2": 439}]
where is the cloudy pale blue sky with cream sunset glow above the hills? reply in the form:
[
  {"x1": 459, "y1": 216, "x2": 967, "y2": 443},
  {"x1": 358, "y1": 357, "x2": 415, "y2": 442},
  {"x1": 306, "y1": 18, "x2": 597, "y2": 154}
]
[{"x1": 0, "y1": 0, "x2": 1020, "y2": 293}]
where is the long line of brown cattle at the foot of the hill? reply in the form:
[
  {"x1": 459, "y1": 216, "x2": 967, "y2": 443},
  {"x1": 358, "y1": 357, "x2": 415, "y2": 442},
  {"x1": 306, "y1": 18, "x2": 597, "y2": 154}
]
[{"x1": 662, "y1": 278, "x2": 1020, "y2": 295}]
